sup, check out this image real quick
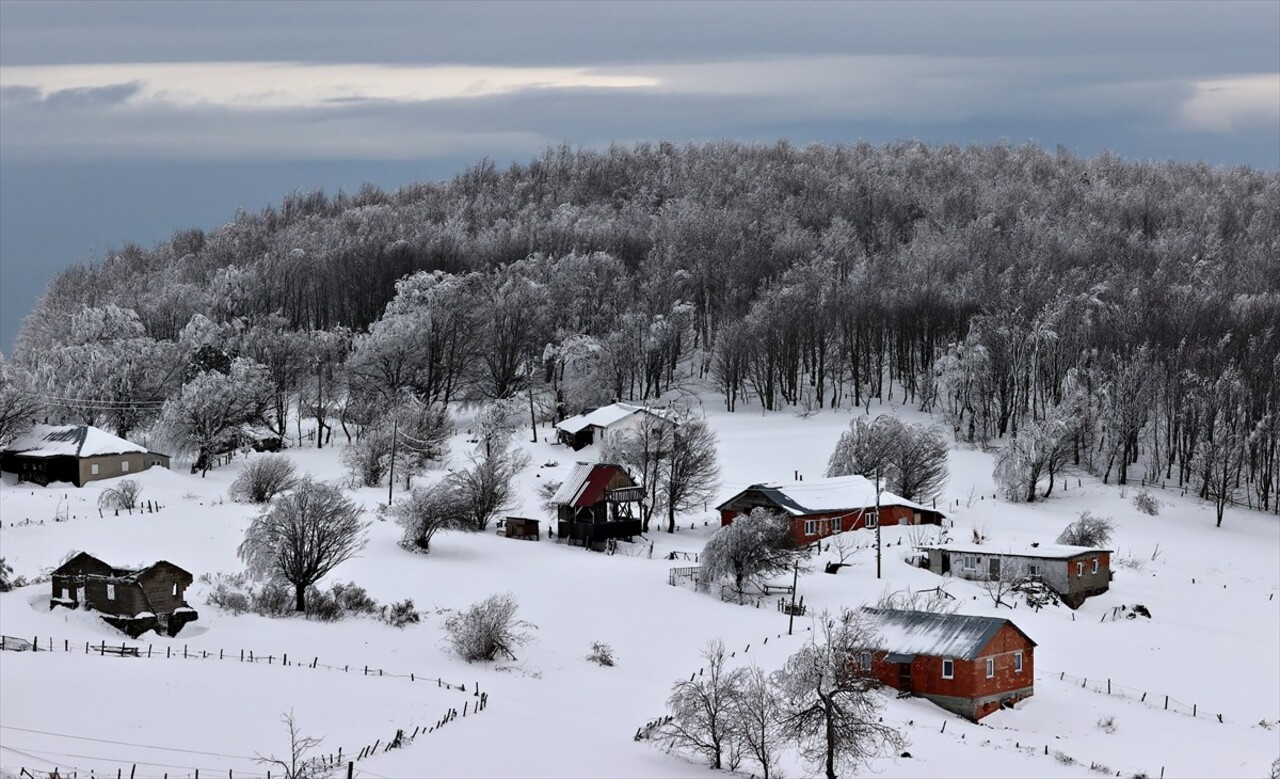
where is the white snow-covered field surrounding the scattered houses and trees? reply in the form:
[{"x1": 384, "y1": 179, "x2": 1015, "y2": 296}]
[{"x1": 0, "y1": 399, "x2": 1280, "y2": 779}]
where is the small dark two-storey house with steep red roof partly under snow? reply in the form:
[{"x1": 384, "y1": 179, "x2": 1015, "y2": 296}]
[{"x1": 552, "y1": 463, "x2": 644, "y2": 546}]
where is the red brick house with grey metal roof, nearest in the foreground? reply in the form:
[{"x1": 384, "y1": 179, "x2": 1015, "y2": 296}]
[{"x1": 858, "y1": 608, "x2": 1036, "y2": 721}]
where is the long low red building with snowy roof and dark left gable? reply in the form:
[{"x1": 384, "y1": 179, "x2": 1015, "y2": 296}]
[{"x1": 716, "y1": 476, "x2": 943, "y2": 545}]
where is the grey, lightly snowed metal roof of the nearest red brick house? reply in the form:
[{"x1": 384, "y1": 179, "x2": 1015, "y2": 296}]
[{"x1": 864, "y1": 608, "x2": 1036, "y2": 660}]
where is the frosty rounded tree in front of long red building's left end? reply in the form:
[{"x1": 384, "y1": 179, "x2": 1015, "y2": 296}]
[{"x1": 699, "y1": 508, "x2": 806, "y2": 602}]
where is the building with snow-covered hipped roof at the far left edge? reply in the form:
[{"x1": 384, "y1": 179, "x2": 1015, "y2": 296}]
[{"x1": 0, "y1": 425, "x2": 169, "y2": 487}]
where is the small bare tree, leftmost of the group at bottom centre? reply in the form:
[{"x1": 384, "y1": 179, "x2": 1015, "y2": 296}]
[{"x1": 658, "y1": 638, "x2": 744, "y2": 769}]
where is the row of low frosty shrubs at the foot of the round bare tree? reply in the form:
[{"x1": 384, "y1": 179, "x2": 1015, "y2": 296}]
[{"x1": 201, "y1": 573, "x2": 421, "y2": 628}]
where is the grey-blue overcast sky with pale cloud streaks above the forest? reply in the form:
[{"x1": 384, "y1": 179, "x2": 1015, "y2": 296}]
[{"x1": 0, "y1": 0, "x2": 1280, "y2": 352}]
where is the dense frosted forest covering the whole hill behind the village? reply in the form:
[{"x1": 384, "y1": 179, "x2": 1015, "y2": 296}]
[{"x1": 0, "y1": 142, "x2": 1280, "y2": 517}]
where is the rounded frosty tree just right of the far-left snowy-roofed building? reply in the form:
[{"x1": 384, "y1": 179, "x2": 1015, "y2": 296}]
[{"x1": 156, "y1": 357, "x2": 271, "y2": 476}]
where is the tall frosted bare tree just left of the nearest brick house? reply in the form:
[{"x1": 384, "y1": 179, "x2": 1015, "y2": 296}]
[{"x1": 774, "y1": 609, "x2": 904, "y2": 779}]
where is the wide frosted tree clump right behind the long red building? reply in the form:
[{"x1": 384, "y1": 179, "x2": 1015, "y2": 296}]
[{"x1": 827, "y1": 414, "x2": 950, "y2": 501}]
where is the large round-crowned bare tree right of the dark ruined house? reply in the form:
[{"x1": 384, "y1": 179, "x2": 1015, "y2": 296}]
[{"x1": 238, "y1": 476, "x2": 365, "y2": 611}]
